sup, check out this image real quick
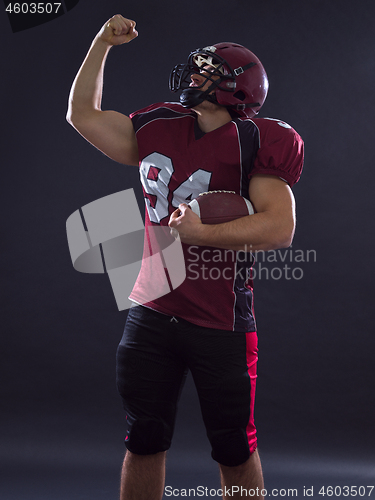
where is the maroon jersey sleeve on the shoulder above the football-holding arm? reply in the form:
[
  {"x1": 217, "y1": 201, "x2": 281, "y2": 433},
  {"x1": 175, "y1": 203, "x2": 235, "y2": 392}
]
[{"x1": 249, "y1": 118, "x2": 304, "y2": 186}]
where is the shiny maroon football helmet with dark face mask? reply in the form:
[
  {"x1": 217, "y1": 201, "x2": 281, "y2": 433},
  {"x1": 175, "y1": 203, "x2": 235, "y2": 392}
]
[{"x1": 169, "y1": 42, "x2": 268, "y2": 118}]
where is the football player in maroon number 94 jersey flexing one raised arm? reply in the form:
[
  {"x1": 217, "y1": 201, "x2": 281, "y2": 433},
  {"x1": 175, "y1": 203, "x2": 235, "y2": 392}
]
[{"x1": 67, "y1": 15, "x2": 303, "y2": 500}]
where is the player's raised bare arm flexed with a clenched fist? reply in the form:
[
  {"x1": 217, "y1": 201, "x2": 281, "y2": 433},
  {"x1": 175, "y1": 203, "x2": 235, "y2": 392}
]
[{"x1": 66, "y1": 15, "x2": 138, "y2": 165}]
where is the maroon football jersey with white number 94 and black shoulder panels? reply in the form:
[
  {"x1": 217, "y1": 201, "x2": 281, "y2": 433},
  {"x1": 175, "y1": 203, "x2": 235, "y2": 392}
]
[{"x1": 130, "y1": 103, "x2": 303, "y2": 331}]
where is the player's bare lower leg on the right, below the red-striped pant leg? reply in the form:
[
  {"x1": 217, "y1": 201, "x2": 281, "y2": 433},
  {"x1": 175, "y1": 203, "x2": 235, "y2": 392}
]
[{"x1": 220, "y1": 450, "x2": 264, "y2": 500}]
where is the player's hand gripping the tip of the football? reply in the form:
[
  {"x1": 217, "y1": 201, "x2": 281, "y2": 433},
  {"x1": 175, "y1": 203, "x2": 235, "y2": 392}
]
[{"x1": 168, "y1": 203, "x2": 203, "y2": 245}]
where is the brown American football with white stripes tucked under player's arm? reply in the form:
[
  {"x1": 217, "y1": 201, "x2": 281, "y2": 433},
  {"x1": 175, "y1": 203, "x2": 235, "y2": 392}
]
[{"x1": 189, "y1": 191, "x2": 254, "y2": 224}]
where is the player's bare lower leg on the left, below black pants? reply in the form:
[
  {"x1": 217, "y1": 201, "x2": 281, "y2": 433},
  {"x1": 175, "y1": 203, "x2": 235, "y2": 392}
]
[{"x1": 120, "y1": 451, "x2": 166, "y2": 500}]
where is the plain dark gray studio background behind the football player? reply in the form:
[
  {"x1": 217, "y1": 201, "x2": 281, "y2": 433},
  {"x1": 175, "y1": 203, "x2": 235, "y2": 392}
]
[{"x1": 0, "y1": 0, "x2": 375, "y2": 500}]
